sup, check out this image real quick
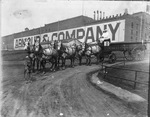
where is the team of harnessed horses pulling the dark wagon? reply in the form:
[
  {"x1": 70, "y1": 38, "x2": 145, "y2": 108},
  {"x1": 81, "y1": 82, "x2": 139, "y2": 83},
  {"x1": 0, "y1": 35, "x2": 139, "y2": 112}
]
[{"x1": 25, "y1": 39, "x2": 106, "y2": 72}]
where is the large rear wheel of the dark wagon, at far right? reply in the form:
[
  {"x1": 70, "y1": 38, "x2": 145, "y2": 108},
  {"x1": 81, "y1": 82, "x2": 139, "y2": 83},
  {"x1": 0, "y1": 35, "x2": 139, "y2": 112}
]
[{"x1": 132, "y1": 48, "x2": 145, "y2": 60}]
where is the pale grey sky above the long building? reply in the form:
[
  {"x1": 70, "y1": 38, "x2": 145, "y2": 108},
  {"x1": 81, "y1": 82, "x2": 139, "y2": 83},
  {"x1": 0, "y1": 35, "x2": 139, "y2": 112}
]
[{"x1": 1, "y1": 0, "x2": 150, "y2": 36}]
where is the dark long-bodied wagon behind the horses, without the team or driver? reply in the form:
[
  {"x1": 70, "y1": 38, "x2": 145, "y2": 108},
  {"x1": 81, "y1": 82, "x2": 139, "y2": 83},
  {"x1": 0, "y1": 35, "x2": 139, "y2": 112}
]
[{"x1": 100, "y1": 40, "x2": 146, "y2": 63}]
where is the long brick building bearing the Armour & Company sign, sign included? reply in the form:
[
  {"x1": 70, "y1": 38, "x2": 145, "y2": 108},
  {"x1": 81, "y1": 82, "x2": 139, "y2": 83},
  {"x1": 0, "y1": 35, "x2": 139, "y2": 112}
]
[{"x1": 2, "y1": 12, "x2": 150, "y2": 50}]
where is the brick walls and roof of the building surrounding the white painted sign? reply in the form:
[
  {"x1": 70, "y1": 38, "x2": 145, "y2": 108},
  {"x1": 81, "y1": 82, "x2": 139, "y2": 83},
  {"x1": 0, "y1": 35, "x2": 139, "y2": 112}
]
[{"x1": 2, "y1": 13, "x2": 150, "y2": 49}]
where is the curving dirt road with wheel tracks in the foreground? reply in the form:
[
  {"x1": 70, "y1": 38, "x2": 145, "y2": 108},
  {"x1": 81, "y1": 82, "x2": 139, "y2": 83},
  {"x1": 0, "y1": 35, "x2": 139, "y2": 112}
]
[{"x1": 1, "y1": 62, "x2": 144, "y2": 117}]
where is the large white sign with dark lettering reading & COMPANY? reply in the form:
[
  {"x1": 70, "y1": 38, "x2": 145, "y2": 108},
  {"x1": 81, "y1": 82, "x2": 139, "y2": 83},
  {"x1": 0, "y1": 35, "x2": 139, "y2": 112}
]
[{"x1": 14, "y1": 20, "x2": 125, "y2": 50}]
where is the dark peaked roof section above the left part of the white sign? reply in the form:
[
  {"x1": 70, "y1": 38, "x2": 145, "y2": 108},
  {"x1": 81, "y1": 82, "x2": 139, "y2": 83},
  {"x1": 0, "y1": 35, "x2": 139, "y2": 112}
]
[{"x1": 4, "y1": 15, "x2": 93, "y2": 38}]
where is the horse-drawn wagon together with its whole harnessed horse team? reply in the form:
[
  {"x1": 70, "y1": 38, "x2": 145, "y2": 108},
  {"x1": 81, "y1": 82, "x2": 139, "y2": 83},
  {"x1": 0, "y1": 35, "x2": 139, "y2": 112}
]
[{"x1": 23, "y1": 38, "x2": 146, "y2": 75}]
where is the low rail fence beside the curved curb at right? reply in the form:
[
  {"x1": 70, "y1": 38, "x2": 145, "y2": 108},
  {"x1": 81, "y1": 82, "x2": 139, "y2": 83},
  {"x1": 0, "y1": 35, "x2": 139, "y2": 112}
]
[{"x1": 103, "y1": 66, "x2": 149, "y2": 89}]
